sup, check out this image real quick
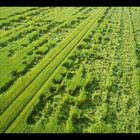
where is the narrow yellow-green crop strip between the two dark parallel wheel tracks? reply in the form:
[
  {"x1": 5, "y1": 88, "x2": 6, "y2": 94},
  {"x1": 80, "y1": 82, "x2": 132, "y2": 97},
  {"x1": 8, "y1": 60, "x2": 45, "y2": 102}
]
[{"x1": 0, "y1": 7, "x2": 105, "y2": 130}]
